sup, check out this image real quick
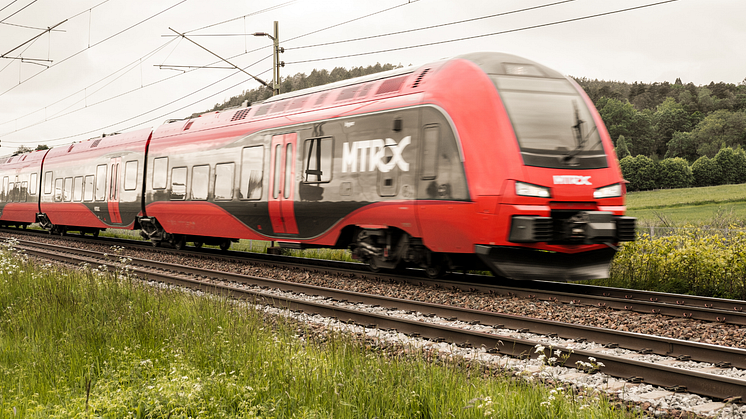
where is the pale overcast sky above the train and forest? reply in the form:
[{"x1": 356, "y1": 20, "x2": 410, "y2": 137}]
[{"x1": 0, "y1": 0, "x2": 746, "y2": 151}]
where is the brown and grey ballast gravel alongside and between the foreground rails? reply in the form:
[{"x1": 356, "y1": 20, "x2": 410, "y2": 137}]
[{"x1": 8, "y1": 232, "x2": 746, "y2": 419}]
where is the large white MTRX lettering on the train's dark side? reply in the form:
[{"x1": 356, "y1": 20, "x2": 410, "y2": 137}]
[{"x1": 342, "y1": 136, "x2": 412, "y2": 173}]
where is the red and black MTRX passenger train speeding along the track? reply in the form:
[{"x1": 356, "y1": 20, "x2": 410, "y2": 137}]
[{"x1": 0, "y1": 52, "x2": 635, "y2": 281}]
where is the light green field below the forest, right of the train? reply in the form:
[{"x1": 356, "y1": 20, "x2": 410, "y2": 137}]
[{"x1": 627, "y1": 184, "x2": 746, "y2": 226}]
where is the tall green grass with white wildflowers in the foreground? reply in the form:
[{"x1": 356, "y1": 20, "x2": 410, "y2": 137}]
[{"x1": 0, "y1": 246, "x2": 626, "y2": 419}]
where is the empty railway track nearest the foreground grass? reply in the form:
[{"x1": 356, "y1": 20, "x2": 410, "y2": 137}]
[{"x1": 10, "y1": 236, "x2": 746, "y2": 400}]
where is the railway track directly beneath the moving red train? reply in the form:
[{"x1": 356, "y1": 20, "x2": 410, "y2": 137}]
[{"x1": 5, "y1": 230, "x2": 746, "y2": 326}]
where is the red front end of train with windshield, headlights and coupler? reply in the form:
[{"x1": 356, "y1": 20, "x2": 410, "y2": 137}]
[{"x1": 450, "y1": 54, "x2": 635, "y2": 281}]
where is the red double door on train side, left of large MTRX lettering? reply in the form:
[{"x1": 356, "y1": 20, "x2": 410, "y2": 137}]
[{"x1": 269, "y1": 133, "x2": 298, "y2": 234}]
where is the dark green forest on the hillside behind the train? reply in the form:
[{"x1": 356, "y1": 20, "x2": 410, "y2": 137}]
[{"x1": 212, "y1": 64, "x2": 746, "y2": 191}]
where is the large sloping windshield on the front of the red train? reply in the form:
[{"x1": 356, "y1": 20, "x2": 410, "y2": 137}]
[{"x1": 490, "y1": 75, "x2": 608, "y2": 169}]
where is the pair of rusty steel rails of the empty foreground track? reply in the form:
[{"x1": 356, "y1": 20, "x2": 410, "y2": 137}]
[{"x1": 14, "y1": 241, "x2": 746, "y2": 399}]
